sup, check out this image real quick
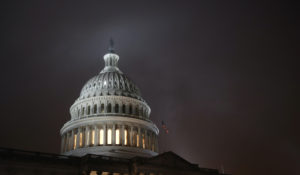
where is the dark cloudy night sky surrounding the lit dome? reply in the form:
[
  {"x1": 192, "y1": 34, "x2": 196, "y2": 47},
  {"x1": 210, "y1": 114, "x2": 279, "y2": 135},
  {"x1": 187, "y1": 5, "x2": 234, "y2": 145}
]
[{"x1": 0, "y1": 0, "x2": 300, "y2": 175}]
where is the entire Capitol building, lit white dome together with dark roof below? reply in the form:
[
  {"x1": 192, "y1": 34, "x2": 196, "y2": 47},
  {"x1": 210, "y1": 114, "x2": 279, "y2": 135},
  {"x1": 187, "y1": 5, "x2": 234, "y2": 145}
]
[{"x1": 0, "y1": 42, "x2": 230, "y2": 175}]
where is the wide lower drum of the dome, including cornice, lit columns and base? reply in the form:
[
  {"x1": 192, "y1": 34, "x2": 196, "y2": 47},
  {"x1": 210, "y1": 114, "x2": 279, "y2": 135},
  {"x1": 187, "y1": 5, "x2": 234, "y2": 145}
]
[{"x1": 61, "y1": 117, "x2": 158, "y2": 158}]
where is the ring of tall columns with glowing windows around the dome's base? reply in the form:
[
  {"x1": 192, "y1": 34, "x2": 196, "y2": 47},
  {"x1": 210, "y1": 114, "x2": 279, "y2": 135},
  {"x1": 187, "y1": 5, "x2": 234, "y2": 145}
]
[{"x1": 61, "y1": 124, "x2": 158, "y2": 153}]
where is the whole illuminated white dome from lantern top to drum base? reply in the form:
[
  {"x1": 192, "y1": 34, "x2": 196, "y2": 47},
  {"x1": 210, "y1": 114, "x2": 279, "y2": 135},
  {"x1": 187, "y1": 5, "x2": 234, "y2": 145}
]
[{"x1": 60, "y1": 42, "x2": 159, "y2": 158}]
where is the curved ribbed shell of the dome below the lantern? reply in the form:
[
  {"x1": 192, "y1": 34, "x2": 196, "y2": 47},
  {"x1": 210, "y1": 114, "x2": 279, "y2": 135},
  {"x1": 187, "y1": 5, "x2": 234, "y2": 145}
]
[{"x1": 79, "y1": 71, "x2": 142, "y2": 100}]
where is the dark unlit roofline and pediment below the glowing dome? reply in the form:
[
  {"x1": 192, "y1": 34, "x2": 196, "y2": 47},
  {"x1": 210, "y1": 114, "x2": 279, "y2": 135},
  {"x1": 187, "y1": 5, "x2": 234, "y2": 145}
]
[{"x1": 0, "y1": 148, "x2": 230, "y2": 175}]
